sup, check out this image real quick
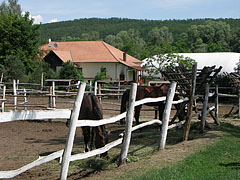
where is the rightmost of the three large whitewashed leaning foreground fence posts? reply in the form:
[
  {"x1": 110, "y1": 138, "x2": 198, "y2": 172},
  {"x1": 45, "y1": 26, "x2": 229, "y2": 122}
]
[{"x1": 158, "y1": 82, "x2": 177, "y2": 149}]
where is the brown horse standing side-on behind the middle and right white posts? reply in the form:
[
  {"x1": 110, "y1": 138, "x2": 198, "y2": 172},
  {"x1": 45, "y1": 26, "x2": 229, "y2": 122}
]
[{"x1": 120, "y1": 84, "x2": 185, "y2": 124}]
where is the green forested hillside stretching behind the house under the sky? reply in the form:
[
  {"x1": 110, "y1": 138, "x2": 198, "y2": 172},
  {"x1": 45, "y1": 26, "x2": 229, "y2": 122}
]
[{"x1": 40, "y1": 18, "x2": 240, "y2": 59}]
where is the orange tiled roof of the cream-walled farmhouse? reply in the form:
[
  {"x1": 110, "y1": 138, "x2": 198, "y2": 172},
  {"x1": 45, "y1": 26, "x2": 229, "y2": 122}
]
[{"x1": 41, "y1": 41, "x2": 142, "y2": 68}]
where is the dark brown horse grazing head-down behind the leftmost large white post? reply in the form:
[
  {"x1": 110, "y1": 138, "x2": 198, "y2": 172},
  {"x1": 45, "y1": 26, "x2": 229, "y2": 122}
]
[{"x1": 66, "y1": 94, "x2": 110, "y2": 159}]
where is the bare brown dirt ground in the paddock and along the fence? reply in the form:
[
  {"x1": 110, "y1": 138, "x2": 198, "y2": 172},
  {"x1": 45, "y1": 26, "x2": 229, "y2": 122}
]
[{"x1": 0, "y1": 99, "x2": 240, "y2": 180}]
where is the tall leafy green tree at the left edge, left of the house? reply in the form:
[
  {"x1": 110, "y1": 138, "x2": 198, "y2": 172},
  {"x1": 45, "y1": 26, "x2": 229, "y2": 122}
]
[{"x1": 0, "y1": 0, "x2": 40, "y2": 81}]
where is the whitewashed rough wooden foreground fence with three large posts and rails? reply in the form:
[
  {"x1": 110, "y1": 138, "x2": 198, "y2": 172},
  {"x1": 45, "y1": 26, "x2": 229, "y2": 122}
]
[{"x1": 0, "y1": 82, "x2": 188, "y2": 180}]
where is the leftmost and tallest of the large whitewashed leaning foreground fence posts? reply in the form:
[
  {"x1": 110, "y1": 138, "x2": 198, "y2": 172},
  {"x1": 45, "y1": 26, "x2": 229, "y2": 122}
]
[{"x1": 60, "y1": 83, "x2": 86, "y2": 180}]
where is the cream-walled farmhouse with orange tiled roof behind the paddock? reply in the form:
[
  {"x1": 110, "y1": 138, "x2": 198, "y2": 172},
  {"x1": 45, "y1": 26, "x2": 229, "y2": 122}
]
[{"x1": 41, "y1": 41, "x2": 142, "y2": 81}]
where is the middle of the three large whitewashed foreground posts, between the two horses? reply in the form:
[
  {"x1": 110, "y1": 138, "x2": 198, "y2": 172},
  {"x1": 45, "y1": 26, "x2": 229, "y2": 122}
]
[{"x1": 118, "y1": 83, "x2": 137, "y2": 166}]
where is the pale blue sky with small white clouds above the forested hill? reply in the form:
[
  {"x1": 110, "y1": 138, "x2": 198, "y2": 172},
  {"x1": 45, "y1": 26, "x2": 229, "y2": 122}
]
[{"x1": 3, "y1": 0, "x2": 240, "y2": 23}]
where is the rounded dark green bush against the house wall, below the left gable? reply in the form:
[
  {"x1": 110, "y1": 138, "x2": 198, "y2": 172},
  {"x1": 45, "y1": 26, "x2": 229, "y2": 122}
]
[{"x1": 59, "y1": 61, "x2": 83, "y2": 81}]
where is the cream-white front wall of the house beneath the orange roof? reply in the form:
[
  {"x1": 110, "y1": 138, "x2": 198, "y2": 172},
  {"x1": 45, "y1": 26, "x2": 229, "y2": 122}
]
[{"x1": 79, "y1": 63, "x2": 132, "y2": 80}]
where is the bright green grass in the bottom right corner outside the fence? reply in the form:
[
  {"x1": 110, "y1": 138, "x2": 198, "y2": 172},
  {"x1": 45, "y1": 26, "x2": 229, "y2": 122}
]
[{"x1": 135, "y1": 123, "x2": 240, "y2": 180}]
